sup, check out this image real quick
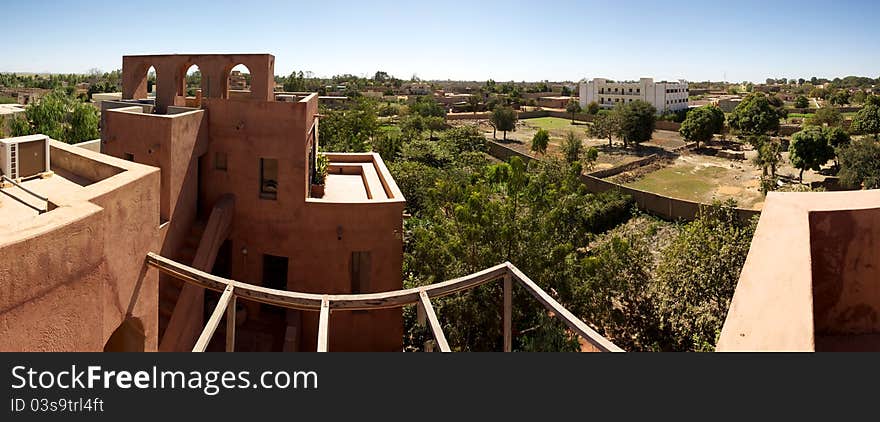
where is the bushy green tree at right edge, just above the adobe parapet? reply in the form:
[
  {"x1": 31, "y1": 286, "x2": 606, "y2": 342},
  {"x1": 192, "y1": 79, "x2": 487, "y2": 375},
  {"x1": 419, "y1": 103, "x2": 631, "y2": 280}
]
[{"x1": 837, "y1": 139, "x2": 880, "y2": 189}]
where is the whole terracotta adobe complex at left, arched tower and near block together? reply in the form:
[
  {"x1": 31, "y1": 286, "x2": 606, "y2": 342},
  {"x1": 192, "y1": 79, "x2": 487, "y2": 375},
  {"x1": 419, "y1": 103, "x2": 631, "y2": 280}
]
[{"x1": 0, "y1": 54, "x2": 405, "y2": 351}]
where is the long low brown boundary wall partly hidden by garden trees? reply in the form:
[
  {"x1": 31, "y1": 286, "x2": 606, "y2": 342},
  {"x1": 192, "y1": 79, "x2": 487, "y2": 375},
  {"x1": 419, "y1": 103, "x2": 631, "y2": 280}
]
[{"x1": 488, "y1": 141, "x2": 761, "y2": 221}]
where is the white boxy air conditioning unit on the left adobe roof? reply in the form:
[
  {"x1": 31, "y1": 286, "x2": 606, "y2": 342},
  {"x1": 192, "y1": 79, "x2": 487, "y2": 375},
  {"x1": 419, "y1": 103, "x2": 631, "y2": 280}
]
[{"x1": 0, "y1": 135, "x2": 49, "y2": 180}]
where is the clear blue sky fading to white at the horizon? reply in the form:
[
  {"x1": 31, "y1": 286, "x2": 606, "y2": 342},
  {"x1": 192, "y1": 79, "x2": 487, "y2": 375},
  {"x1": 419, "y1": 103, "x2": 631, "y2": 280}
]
[{"x1": 0, "y1": 0, "x2": 880, "y2": 81}]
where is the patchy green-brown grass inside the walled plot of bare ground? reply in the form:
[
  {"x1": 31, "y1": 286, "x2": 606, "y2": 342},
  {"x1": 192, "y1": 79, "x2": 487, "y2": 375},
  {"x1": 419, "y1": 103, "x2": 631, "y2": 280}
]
[{"x1": 627, "y1": 166, "x2": 724, "y2": 201}]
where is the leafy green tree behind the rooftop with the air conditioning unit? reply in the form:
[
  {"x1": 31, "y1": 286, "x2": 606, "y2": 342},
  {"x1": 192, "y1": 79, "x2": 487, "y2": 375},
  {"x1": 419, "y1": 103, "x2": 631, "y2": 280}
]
[{"x1": 10, "y1": 91, "x2": 100, "y2": 144}]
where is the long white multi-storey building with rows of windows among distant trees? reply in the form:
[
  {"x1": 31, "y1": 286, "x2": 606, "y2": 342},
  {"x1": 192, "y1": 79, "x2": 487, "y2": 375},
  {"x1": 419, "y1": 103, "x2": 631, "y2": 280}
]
[{"x1": 580, "y1": 78, "x2": 688, "y2": 113}]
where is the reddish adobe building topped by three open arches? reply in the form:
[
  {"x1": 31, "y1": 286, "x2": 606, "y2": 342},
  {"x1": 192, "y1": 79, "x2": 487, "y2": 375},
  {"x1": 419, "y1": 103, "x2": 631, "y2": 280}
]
[{"x1": 101, "y1": 54, "x2": 405, "y2": 351}]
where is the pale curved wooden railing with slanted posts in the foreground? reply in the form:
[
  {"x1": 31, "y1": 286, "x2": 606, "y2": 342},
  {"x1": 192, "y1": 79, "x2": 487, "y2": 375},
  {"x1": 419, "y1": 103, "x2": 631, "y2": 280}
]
[{"x1": 147, "y1": 252, "x2": 623, "y2": 352}]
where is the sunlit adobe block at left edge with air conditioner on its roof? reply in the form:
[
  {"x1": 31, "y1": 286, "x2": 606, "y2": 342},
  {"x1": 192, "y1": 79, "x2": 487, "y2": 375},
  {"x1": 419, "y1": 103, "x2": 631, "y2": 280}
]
[{"x1": 0, "y1": 135, "x2": 160, "y2": 351}]
